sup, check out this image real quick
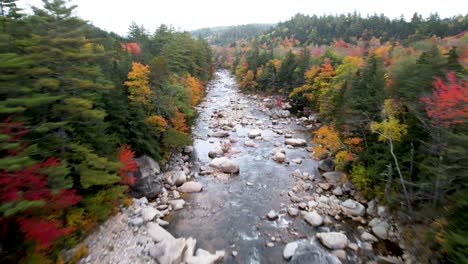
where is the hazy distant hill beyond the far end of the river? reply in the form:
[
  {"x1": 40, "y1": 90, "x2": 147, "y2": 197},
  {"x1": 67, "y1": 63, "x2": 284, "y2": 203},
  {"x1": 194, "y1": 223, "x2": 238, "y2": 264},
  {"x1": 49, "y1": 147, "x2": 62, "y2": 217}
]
[{"x1": 191, "y1": 24, "x2": 275, "y2": 45}]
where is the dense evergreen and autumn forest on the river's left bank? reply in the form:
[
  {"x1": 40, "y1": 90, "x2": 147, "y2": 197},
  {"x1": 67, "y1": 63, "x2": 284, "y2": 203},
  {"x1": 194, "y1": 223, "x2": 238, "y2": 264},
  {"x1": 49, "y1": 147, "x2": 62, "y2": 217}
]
[{"x1": 0, "y1": 0, "x2": 213, "y2": 263}]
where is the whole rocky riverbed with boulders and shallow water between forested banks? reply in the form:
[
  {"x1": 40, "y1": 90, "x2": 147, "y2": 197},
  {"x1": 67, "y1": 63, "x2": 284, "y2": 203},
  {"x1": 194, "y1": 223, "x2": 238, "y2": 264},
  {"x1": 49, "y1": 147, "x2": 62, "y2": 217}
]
[{"x1": 77, "y1": 71, "x2": 414, "y2": 263}]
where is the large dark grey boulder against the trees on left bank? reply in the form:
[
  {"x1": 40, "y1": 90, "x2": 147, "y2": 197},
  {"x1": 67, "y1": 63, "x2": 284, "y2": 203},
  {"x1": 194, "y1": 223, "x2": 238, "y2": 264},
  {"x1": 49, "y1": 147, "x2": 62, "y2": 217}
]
[{"x1": 130, "y1": 156, "x2": 163, "y2": 198}]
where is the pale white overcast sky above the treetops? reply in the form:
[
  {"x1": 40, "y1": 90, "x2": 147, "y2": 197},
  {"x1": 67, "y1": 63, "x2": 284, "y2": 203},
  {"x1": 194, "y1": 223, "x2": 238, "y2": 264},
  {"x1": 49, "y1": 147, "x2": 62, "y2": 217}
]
[{"x1": 19, "y1": 0, "x2": 468, "y2": 35}]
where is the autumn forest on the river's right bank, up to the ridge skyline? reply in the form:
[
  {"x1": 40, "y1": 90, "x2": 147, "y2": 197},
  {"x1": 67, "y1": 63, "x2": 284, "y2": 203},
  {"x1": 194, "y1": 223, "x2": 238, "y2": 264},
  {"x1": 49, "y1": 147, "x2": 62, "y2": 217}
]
[{"x1": 215, "y1": 11, "x2": 468, "y2": 263}]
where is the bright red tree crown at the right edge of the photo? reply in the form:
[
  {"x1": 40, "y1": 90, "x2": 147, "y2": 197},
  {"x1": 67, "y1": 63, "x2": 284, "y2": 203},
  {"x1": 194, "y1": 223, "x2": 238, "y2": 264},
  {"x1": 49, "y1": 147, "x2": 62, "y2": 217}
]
[{"x1": 421, "y1": 72, "x2": 468, "y2": 127}]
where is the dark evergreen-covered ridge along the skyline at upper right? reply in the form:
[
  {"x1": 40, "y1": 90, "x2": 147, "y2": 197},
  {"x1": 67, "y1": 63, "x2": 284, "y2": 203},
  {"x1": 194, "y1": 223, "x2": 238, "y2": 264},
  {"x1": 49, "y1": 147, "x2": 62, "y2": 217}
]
[{"x1": 259, "y1": 13, "x2": 468, "y2": 45}]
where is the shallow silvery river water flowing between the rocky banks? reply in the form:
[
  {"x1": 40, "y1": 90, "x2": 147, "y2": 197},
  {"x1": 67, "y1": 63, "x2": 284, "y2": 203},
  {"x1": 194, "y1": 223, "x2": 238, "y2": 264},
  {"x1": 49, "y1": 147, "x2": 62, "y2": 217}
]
[{"x1": 168, "y1": 70, "x2": 354, "y2": 263}]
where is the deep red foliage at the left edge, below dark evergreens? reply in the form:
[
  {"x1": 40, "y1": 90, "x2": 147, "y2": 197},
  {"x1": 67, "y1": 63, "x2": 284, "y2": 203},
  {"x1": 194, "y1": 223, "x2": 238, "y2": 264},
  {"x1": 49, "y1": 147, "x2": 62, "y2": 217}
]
[{"x1": 0, "y1": 117, "x2": 81, "y2": 249}]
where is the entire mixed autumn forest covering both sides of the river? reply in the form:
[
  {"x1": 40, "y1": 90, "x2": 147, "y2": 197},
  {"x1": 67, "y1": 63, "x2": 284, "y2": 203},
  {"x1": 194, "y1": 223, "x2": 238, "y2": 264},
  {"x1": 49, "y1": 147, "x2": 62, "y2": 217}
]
[{"x1": 0, "y1": 0, "x2": 468, "y2": 263}]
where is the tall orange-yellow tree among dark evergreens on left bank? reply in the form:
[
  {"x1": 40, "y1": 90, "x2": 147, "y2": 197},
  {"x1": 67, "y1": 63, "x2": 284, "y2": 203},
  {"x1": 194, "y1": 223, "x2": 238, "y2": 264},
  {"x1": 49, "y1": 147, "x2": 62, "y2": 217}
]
[{"x1": 124, "y1": 62, "x2": 152, "y2": 105}]
